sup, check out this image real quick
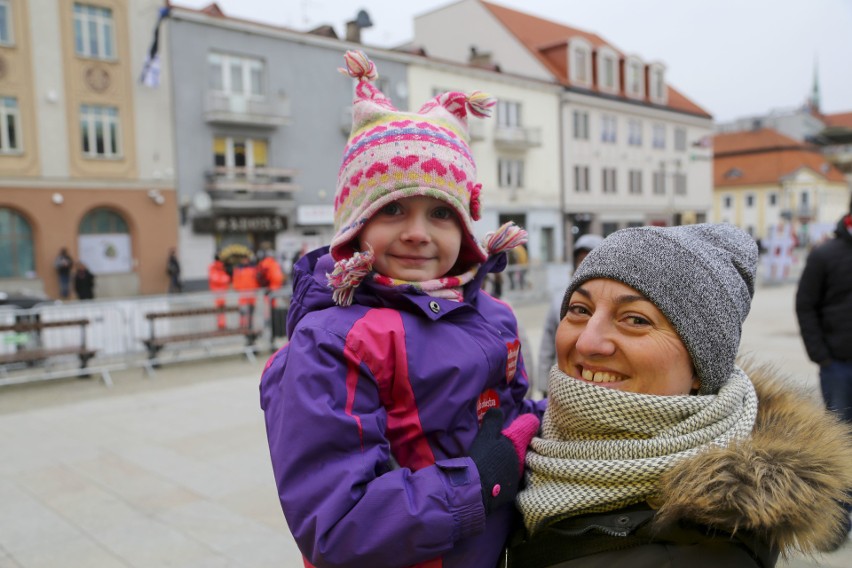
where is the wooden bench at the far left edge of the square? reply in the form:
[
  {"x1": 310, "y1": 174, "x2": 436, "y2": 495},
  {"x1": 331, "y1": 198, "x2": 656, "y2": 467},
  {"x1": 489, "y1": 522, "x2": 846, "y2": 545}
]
[{"x1": 0, "y1": 319, "x2": 97, "y2": 376}]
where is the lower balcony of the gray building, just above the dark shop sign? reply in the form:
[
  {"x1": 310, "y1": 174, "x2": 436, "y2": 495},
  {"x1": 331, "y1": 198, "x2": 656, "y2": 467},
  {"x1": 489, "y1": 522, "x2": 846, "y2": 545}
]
[{"x1": 204, "y1": 167, "x2": 299, "y2": 208}]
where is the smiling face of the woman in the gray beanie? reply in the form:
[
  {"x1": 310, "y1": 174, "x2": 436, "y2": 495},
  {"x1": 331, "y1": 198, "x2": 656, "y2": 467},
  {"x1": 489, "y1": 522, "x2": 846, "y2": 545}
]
[{"x1": 556, "y1": 279, "x2": 700, "y2": 395}]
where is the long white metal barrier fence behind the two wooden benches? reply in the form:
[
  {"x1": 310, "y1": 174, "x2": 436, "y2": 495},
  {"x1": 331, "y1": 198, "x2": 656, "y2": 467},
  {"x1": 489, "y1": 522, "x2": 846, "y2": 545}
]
[{"x1": 0, "y1": 290, "x2": 289, "y2": 386}]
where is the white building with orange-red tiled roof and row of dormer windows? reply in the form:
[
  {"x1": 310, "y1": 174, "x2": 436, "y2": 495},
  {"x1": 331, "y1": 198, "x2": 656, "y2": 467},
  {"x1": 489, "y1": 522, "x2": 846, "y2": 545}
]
[{"x1": 414, "y1": 0, "x2": 713, "y2": 255}]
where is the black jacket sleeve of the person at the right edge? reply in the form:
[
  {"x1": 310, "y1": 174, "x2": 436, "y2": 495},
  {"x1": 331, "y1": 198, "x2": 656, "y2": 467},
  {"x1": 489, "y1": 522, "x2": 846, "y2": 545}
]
[{"x1": 796, "y1": 249, "x2": 831, "y2": 364}]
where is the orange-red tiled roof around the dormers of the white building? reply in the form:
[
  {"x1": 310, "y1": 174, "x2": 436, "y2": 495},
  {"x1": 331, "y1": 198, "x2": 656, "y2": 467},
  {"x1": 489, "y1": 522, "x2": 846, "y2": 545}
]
[{"x1": 481, "y1": 1, "x2": 711, "y2": 118}]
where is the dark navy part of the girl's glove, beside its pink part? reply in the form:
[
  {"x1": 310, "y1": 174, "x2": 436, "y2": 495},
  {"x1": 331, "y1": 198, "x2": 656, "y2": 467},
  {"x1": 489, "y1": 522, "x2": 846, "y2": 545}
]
[{"x1": 468, "y1": 408, "x2": 521, "y2": 515}]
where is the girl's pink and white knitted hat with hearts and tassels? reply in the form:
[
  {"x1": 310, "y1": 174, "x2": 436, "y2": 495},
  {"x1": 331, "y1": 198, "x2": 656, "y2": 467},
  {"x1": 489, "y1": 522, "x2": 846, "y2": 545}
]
[{"x1": 331, "y1": 51, "x2": 496, "y2": 270}]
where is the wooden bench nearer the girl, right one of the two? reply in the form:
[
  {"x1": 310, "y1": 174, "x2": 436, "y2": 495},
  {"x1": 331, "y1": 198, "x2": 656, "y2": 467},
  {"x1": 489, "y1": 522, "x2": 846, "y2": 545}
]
[{"x1": 142, "y1": 306, "x2": 260, "y2": 373}]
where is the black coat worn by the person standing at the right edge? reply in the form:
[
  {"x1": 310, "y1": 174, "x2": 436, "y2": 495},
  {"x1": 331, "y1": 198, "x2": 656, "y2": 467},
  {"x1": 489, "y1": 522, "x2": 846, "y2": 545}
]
[{"x1": 796, "y1": 215, "x2": 852, "y2": 364}]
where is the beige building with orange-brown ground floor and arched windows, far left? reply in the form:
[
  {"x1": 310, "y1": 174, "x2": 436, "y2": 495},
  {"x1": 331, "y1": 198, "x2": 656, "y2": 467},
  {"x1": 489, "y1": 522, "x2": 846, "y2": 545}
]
[{"x1": 0, "y1": 0, "x2": 178, "y2": 298}]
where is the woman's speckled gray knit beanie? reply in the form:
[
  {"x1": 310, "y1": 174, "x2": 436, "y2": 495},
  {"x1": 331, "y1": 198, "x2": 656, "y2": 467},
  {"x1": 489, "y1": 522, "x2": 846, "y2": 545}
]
[{"x1": 560, "y1": 223, "x2": 758, "y2": 394}]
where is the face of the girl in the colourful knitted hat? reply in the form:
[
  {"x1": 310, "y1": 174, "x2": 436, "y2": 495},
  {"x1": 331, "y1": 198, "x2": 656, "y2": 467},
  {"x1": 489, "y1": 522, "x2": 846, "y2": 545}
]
[{"x1": 360, "y1": 196, "x2": 462, "y2": 282}]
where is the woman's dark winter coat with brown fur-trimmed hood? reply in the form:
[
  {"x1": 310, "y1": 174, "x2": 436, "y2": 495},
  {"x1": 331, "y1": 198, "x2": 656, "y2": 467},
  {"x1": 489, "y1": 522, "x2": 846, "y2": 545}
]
[{"x1": 504, "y1": 368, "x2": 852, "y2": 568}]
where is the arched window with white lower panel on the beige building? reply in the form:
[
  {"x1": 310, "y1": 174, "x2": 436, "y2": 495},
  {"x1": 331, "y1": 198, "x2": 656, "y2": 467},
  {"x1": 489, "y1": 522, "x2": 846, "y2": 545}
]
[{"x1": 78, "y1": 208, "x2": 133, "y2": 274}]
